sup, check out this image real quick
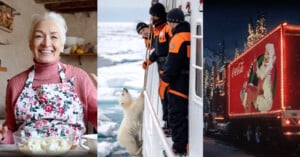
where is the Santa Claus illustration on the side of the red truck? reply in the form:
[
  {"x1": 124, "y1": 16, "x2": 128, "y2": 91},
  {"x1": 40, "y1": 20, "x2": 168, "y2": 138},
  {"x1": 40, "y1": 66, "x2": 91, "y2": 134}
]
[{"x1": 241, "y1": 43, "x2": 276, "y2": 112}]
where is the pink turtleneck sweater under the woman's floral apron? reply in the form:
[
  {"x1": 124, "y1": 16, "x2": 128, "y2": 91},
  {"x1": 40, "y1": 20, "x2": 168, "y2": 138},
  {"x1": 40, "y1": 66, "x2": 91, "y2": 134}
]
[{"x1": 1, "y1": 60, "x2": 97, "y2": 143}]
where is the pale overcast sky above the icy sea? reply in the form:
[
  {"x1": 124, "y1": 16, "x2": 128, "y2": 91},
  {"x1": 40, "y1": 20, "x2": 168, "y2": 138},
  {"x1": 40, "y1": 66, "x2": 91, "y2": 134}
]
[{"x1": 98, "y1": 0, "x2": 151, "y2": 22}]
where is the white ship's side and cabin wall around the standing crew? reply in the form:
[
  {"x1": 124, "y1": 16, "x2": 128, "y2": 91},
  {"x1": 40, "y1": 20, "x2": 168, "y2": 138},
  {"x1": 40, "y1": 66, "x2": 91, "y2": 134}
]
[{"x1": 143, "y1": 0, "x2": 203, "y2": 157}]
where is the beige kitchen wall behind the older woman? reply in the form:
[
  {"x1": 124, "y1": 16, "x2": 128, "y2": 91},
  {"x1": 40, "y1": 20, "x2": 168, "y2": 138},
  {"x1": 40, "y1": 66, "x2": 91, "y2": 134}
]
[{"x1": 0, "y1": 0, "x2": 97, "y2": 119}]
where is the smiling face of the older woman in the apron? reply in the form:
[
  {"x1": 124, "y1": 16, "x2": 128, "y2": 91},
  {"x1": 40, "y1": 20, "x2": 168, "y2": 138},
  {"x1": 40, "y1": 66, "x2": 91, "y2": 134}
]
[{"x1": 30, "y1": 19, "x2": 64, "y2": 63}]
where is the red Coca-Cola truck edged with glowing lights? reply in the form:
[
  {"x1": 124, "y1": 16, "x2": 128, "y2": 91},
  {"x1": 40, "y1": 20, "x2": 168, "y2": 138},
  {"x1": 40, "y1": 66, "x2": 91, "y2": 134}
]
[{"x1": 205, "y1": 23, "x2": 300, "y2": 146}]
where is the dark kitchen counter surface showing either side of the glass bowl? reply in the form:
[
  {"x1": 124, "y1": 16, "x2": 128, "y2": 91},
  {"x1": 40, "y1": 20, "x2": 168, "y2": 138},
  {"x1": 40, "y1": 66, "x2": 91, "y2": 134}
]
[{"x1": 0, "y1": 144, "x2": 97, "y2": 157}]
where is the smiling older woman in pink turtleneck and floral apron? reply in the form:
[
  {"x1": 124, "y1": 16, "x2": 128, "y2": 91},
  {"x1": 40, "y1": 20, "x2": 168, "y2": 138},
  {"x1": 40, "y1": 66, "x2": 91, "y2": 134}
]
[{"x1": 0, "y1": 12, "x2": 97, "y2": 143}]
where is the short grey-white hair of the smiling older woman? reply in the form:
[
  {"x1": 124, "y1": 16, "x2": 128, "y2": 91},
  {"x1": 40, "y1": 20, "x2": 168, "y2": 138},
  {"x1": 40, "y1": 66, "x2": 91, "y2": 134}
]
[{"x1": 29, "y1": 12, "x2": 68, "y2": 44}]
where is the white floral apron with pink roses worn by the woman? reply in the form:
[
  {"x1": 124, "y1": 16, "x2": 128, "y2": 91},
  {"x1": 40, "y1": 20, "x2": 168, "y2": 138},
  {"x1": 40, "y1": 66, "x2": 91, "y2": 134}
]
[{"x1": 15, "y1": 65, "x2": 85, "y2": 143}]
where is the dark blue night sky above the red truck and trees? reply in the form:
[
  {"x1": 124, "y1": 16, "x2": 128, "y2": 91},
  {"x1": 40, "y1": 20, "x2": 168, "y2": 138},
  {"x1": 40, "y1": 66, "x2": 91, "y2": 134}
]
[{"x1": 203, "y1": 0, "x2": 300, "y2": 65}]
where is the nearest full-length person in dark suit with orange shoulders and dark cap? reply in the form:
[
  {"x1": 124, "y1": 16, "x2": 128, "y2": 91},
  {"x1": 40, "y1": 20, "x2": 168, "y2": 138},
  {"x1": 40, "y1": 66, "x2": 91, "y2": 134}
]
[{"x1": 159, "y1": 8, "x2": 191, "y2": 155}]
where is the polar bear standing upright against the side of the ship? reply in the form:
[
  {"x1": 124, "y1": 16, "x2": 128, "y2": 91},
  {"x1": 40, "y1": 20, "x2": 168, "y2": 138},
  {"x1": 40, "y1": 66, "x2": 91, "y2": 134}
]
[{"x1": 117, "y1": 88, "x2": 144, "y2": 156}]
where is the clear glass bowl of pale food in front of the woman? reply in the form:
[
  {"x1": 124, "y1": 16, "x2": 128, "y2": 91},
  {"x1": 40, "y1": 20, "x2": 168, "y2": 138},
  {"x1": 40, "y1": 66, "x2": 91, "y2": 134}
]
[{"x1": 13, "y1": 132, "x2": 74, "y2": 157}]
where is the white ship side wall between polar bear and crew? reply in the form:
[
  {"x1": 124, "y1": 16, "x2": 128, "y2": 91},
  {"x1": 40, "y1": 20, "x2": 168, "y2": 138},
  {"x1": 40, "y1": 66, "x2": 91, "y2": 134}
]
[{"x1": 143, "y1": 63, "x2": 175, "y2": 157}]
